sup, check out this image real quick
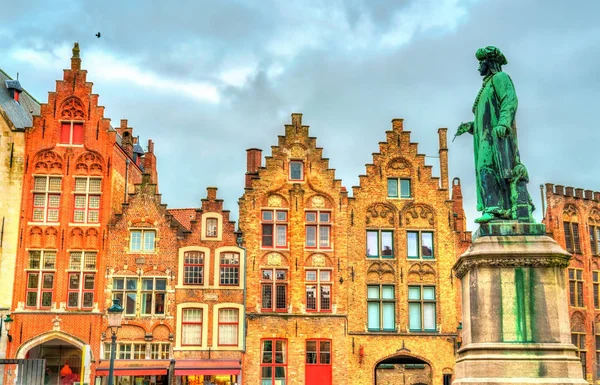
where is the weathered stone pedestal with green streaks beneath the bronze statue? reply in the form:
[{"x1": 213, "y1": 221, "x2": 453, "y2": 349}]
[{"x1": 453, "y1": 222, "x2": 587, "y2": 385}]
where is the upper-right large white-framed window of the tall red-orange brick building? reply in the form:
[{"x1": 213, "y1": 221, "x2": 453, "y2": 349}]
[{"x1": 73, "y1": 178, "x2": 102, "y2": 223}]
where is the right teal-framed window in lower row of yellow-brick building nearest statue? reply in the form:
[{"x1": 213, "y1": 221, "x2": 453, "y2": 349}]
[{"x1": 408, "y1": 286, "x2": 436, "y2": 331}]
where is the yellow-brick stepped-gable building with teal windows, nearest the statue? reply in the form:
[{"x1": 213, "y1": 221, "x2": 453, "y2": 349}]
[{"x1": 344, "y1": 119, "x2": 471, "y2": 384}]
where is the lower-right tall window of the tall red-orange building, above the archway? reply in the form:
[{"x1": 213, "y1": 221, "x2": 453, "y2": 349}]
[{"x1": 67, "y1": 251, "x2": 96, "y2": 309}]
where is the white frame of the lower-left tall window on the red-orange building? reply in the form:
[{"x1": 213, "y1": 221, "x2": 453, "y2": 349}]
[{"x1": 25, "y1": 249, "x2": 58, "y2": 310}]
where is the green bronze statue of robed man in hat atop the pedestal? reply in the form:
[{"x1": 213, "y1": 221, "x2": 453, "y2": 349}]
[{"x1": 456, "y1": 46, "x2": 534, "y2": 223}]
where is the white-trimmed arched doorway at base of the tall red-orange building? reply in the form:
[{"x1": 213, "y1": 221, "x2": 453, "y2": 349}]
[{"x1": 16, "y1": 332, "x2": 92, "y2": 385}]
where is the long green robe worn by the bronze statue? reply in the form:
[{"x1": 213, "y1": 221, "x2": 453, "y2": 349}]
[{"x1": 473, "y1": 72, "x2": 520, "y2": 219}]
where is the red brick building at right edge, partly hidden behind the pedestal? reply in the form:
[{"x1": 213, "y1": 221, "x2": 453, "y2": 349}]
[{"x1": 543, "y1": 183, "x2": 600, "y2": 383}]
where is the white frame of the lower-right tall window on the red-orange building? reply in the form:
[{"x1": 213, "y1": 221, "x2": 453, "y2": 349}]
[{"x1": 66, "y1": 250, "x2": 98, "y2": 310}]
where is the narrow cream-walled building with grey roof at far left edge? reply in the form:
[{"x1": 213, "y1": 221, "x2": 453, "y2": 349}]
[{"x1": 0, "y1": 70, "x2": 40, "y2": 380}]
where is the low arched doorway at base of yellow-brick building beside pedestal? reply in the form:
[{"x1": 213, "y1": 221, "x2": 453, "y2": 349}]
[{"x1": 374, "y1": 354, "x2": 433, "y2": 385}]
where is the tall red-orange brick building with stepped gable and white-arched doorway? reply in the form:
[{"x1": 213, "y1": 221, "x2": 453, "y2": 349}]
[{"x1": 6, "y1": 43, "x2": 143, "y2": 384}]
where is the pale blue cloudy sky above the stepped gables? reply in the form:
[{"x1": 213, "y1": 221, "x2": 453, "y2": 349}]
[{"x1": 0, "y1": 0, "x2": 600, "y2": 229}]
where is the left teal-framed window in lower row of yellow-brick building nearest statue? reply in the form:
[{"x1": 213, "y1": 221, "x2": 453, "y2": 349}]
[{"x1": 367, "y1": 285, "x2": 396, "y2": 331}]
